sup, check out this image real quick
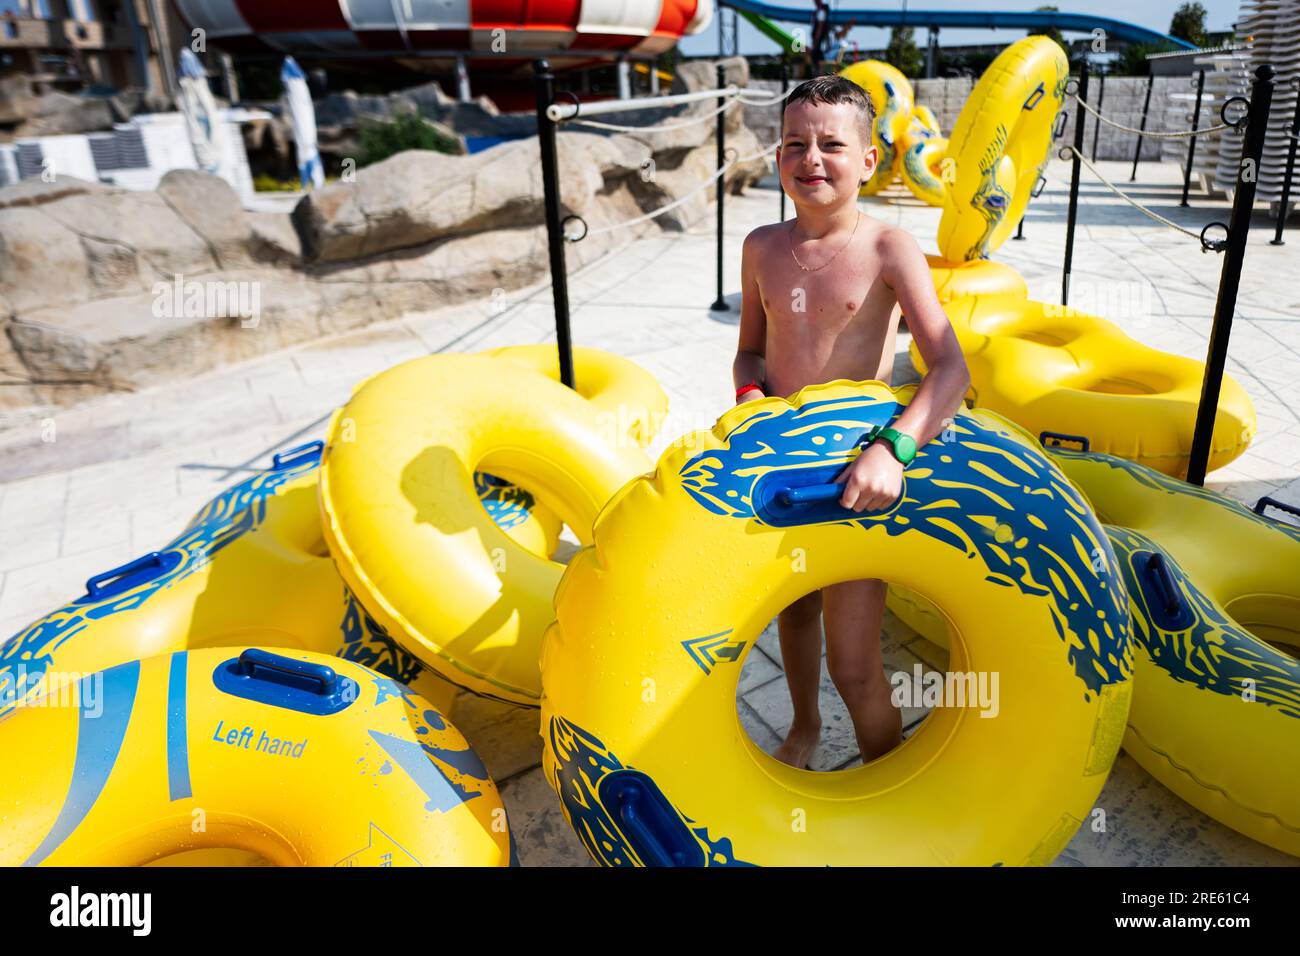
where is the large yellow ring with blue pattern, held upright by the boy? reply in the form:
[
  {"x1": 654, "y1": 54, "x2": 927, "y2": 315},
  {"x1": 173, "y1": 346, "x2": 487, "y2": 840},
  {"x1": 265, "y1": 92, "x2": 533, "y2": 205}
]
[{"x1": 542, "y1": 381, "x2": 1131, "y2": 866}]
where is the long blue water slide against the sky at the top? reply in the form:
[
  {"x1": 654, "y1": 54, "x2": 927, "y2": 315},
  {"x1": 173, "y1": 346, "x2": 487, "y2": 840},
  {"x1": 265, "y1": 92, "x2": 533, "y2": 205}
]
[{"x1": 718, "y1": 0, "x2": 1195, "y2": 52}]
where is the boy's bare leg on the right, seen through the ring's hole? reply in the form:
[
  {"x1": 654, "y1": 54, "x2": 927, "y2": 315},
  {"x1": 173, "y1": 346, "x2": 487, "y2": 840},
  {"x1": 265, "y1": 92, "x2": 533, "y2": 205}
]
[{"x1": 822, "y1": 580, "x2": 902, "y2": 763}]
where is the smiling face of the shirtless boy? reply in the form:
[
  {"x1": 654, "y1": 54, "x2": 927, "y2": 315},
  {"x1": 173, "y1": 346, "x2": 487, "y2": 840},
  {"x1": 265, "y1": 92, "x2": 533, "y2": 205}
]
[{"x1": 776, "y1": 100, "x2": 878, "y2": 208}]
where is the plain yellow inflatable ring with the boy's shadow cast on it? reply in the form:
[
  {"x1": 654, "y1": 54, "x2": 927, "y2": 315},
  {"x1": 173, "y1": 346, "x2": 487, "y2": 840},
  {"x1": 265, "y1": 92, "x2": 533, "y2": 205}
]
[{"x1": 320, "y1": 355, "x2": 649, "y2": 706}]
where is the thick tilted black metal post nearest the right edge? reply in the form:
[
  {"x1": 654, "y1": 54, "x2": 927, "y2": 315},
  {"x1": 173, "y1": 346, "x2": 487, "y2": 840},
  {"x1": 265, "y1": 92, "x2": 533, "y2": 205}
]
[{"x1": 1187, "y1": 64, "x2": 1273, "y2": 485}]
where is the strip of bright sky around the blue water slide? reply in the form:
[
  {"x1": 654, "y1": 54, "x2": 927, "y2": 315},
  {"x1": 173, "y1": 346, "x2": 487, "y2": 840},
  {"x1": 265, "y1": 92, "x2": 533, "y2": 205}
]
[{"x1": 679, "y1": 0, "x2": 1240, "y2": 56}]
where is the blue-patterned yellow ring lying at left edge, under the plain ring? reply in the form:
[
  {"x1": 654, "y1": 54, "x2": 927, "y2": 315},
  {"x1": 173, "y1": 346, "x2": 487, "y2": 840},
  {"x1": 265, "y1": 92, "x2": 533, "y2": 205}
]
[{"x1": 0, "y1": 441, "x2": 455, "y2": 717}]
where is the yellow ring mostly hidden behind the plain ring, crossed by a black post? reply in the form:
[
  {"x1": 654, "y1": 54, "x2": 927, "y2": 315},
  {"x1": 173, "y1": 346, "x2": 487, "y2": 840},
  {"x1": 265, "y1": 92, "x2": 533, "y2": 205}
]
[{"x1": 482, "y1": 345, "x2": 668, "y2": 447}]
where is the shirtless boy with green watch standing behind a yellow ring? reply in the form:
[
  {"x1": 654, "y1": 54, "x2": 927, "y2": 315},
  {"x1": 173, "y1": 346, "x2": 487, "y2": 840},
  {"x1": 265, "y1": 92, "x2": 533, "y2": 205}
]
[{"x1": 732, "y1": 77, "x2": 970, "y2": 767}]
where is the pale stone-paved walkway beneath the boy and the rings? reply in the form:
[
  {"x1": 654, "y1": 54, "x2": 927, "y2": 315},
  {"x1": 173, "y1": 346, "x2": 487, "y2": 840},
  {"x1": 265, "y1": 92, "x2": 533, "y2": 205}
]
[{"x1": 0, "y1": 163, "x2": 1300, "y2": 865}]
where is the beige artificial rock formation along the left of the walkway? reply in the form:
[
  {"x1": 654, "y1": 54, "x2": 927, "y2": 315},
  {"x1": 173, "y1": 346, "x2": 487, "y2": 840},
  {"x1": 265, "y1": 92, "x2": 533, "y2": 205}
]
[{"x1": 0, "y1": 65, "x2": 767, "y2": 425}]
